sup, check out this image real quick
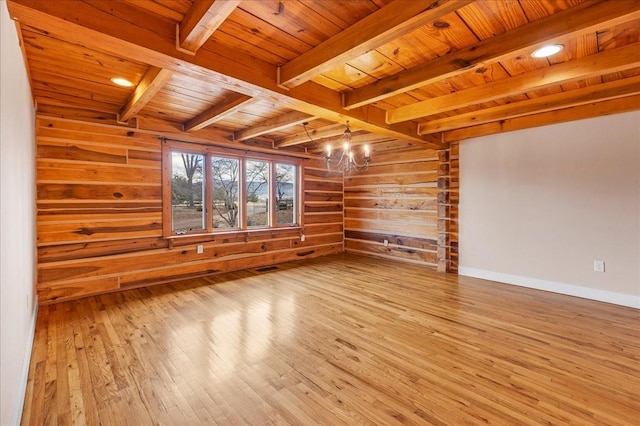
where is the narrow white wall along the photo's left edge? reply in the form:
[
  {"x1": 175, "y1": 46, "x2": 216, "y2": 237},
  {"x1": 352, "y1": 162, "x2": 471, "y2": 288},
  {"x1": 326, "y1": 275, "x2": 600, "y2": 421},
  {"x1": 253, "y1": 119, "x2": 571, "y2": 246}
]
[{"x1": 0, "y1": 1, "x2": 37, "y2": 426}]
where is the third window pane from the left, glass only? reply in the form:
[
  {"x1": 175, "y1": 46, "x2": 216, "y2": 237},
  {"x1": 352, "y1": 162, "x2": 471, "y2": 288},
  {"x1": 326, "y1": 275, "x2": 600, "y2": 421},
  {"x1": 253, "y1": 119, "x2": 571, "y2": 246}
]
[{"x1": 245, "y1": 160, "x2": 269, "y2": 227}]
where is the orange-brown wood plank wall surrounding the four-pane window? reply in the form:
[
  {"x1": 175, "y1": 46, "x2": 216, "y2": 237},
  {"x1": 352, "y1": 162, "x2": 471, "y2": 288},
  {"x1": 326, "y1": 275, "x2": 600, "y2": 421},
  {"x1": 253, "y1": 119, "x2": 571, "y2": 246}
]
[{"x1": 36, "y1": 114, "x2": 344, "y2": 303}]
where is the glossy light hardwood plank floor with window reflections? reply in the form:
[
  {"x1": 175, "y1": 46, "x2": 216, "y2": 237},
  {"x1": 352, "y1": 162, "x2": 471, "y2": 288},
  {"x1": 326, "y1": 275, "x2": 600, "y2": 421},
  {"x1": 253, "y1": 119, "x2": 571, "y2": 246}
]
[{"x1": 23, "y1": 255, "x2": 640, "y2": 425}]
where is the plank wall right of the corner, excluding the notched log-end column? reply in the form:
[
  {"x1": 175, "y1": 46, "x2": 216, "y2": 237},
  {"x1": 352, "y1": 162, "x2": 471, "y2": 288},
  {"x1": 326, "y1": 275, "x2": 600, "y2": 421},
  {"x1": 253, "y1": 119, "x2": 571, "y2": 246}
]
[{"x1": 344, "y1": 148, "x2": 440, "y2": 268}]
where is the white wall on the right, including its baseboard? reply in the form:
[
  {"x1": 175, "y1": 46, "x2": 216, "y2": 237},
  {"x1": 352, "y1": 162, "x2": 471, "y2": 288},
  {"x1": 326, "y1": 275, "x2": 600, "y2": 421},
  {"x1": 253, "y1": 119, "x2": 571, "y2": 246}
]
[{"x1": 460, "y1": 111, "x2": 640, "y2": 308}]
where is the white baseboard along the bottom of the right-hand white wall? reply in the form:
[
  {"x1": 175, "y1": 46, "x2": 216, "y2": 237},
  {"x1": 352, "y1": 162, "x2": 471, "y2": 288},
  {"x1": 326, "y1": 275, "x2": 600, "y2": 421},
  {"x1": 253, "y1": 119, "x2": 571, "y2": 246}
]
[{"x1": 458, "y1": 266, "x2": 640, "y2": 309}]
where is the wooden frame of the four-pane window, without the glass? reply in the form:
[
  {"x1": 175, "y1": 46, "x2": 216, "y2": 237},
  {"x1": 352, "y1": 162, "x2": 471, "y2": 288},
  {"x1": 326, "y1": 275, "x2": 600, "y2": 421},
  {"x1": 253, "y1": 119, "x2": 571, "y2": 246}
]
[{"x1": 162, "y1": 139, "x2": 304, "y2": 239}]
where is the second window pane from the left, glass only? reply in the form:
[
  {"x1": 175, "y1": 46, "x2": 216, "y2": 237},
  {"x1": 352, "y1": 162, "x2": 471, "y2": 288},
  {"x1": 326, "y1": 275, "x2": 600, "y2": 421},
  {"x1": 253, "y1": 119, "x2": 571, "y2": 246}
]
[{"x1": 211, "y1": 157, "x2": 240, "y2": 228}]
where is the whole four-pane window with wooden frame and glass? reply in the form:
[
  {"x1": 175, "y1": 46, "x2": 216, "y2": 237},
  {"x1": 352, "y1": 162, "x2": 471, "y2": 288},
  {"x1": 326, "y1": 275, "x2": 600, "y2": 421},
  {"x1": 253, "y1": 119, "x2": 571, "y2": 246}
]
[{"x1": 163, "y1": 140, "x2": 300, "y2": 236}]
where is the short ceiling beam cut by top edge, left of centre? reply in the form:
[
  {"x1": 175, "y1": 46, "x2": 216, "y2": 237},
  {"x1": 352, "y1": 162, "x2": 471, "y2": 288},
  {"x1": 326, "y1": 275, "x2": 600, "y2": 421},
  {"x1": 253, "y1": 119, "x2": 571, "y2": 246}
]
[{"x1": 176, "y1": 0, "x2": 240, "y2": 54}]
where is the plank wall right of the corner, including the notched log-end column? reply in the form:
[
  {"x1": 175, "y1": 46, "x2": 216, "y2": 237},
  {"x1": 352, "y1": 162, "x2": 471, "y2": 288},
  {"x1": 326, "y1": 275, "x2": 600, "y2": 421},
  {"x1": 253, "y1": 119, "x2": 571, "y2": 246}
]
[{"x1": 344, "y1": 144, "x2": 458, "y2": 272}]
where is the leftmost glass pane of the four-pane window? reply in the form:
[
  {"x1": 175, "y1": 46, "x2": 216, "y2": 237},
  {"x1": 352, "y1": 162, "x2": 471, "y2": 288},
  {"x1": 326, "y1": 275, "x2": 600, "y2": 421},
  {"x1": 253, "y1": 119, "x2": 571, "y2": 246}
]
[{"x1": 171, "y1": 152, "x2": 205, "y2": 233}]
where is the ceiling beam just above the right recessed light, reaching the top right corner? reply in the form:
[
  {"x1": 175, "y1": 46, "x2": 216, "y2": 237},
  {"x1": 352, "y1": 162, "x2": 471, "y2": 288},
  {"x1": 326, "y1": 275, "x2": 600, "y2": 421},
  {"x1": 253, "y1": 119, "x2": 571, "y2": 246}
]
[{"x1": 343, "y1": 0, "x2": 640, "y2": 109}]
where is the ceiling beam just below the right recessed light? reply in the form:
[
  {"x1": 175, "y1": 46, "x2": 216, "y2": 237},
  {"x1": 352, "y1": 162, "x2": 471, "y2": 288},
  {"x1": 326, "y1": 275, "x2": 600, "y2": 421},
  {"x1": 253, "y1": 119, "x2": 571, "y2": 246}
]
[{"x1": 387, "y1": 42, "x2": 640, "y2": 123}]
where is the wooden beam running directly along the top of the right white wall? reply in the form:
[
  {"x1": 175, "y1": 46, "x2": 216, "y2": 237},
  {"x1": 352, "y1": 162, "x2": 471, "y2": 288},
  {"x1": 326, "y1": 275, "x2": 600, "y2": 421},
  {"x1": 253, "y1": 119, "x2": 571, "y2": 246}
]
[{"x1": 443, "y1": 95, "x2": 640, "y2": 143}]
